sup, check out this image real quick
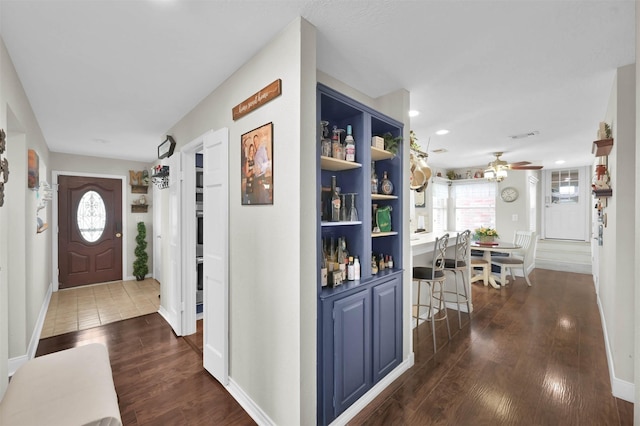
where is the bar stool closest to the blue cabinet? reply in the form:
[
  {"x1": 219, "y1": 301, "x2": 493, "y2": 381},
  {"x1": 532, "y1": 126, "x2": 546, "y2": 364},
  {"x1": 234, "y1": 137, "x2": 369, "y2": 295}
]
[{"x1": 413, "y1": 234, "x2": 451, "y2": 353}]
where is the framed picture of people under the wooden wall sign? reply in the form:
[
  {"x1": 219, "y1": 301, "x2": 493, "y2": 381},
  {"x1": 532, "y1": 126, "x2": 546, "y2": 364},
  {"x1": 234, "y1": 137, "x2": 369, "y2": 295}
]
[{"x1": 240, "y1": 123, "x2": 273, "y2": 205}]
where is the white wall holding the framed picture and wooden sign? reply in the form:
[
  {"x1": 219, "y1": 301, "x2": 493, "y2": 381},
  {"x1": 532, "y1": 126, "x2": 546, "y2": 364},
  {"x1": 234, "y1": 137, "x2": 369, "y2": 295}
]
[{"x1": 163, "y1": 19, "x2": 316, "y2": 425}]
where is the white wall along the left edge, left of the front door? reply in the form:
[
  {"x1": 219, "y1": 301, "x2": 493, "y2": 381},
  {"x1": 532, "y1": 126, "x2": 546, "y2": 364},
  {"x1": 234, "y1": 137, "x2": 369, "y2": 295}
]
[{"x1": 0, "y1": 39, "x2": 51, "y2": 395}]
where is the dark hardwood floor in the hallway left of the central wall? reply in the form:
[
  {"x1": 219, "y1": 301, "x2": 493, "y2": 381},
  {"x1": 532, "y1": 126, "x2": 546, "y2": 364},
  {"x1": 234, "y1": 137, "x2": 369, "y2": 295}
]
[{"x1": 36, "y1": 314, "x2": 255, "y2": 425}]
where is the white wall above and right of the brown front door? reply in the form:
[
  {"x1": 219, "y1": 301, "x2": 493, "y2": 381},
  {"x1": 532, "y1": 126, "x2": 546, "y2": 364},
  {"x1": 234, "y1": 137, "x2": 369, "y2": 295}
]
[{"x1": 50, "y1": 152, "x2": 154, "y2": 279}]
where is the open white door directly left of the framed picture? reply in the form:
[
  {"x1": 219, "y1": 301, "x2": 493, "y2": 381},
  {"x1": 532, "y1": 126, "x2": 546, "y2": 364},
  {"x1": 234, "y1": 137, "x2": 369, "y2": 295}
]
[{"x1": 203, "y1": 128, "x2": 229, "y2": 386}]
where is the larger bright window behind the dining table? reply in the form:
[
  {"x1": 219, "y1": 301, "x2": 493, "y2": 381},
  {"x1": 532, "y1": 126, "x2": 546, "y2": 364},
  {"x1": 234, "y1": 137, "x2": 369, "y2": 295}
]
[{"x1": 452, "y1": 181, "x2": 496, "y2": 231}]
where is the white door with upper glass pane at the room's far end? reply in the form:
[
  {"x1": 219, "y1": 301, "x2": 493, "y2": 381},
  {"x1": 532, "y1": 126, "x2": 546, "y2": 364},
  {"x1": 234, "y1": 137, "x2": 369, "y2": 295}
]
[{"x1": 543, "y1": 167, "x2": 591, "y2": 241}]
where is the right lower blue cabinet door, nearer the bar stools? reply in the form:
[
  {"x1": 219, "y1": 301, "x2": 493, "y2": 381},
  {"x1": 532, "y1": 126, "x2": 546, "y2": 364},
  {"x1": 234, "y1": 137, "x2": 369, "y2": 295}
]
[{"x1": 372, "y1": 277, "x2": 402, "y2": 384}]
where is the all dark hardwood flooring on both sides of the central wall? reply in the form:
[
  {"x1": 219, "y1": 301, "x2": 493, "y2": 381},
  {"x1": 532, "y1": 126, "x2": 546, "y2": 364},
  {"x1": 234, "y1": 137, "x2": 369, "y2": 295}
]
[{"x1": 37, "y1": 269, "x2": 633, "y2": 426}]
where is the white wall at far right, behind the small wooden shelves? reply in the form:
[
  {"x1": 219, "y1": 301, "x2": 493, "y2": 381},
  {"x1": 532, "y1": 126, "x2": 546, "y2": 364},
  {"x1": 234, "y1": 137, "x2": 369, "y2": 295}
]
[{"x1": 597, "y1": 65, "x2": 636, "y2": 401}]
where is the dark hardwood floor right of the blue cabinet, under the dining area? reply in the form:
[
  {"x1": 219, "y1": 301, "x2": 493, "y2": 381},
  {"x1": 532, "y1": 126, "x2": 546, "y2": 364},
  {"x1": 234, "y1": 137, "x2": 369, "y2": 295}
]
[{"x1": 350, "y1": 269, "x2": 633, "y2": 426}]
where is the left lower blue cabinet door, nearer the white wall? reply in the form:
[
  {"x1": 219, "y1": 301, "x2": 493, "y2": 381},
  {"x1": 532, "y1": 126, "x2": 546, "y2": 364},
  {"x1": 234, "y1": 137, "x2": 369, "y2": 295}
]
[{"x1": 333, "y1": 290, "x2": 371, "y2": 416}]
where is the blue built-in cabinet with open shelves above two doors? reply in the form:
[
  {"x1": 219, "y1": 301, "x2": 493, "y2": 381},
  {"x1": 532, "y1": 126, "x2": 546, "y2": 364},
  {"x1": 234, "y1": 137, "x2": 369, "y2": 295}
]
[{"x1": 316, "y1": 84, "x2": 406, "y2": 425}]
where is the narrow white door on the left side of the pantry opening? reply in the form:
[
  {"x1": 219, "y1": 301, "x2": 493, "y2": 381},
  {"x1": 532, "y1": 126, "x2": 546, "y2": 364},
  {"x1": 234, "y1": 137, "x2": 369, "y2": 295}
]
[{"x1": 165, "y1": 152, "x2": 182, "y2": 336}]
